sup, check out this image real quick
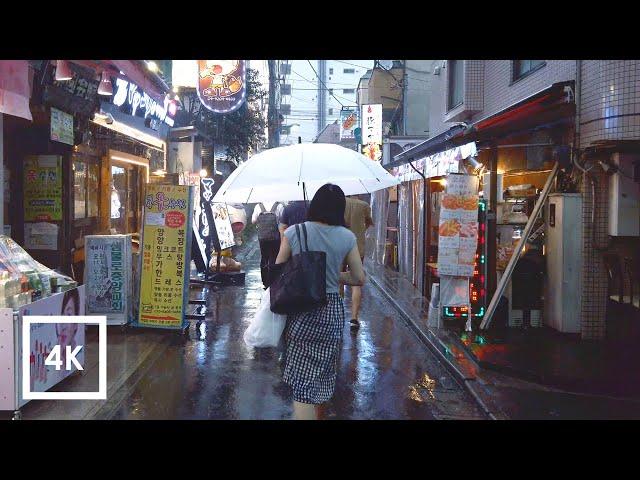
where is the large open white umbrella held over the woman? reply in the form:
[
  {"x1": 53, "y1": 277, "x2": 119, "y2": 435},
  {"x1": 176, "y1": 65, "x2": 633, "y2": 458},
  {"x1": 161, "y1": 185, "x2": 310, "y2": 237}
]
[{"x1": 213, "y1": 143, "x2": 400, "y2": 203}]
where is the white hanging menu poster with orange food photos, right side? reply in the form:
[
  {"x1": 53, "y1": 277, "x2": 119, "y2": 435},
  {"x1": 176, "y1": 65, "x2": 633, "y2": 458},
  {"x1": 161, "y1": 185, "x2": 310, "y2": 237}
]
[{"x1": 438, "y1": 175, "x2": 478, "y2": 277}]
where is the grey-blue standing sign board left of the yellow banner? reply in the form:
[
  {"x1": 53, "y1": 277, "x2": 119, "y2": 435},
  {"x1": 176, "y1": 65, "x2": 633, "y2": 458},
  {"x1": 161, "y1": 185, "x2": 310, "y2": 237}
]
[{"x1": 84, "y1": 235, "x2": 133, "y2": 325}]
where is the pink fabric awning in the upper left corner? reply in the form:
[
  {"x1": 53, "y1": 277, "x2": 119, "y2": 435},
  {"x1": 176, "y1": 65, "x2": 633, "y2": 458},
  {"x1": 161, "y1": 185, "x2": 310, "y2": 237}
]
[{"x1": 0, "y1": 60, "x2": 33, "y2": 120}]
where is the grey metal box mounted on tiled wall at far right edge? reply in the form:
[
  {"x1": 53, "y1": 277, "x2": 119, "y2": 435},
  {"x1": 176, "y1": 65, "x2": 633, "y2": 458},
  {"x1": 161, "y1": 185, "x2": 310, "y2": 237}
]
[{"x1": 609, "y1": 153, "x2": 640, "y2": 237}]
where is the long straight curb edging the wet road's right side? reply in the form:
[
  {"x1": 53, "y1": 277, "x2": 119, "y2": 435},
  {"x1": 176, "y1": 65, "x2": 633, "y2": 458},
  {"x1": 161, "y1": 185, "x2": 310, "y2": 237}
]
[{"x1": 369, "y1": 275, "x2": 502, "y2": 420}]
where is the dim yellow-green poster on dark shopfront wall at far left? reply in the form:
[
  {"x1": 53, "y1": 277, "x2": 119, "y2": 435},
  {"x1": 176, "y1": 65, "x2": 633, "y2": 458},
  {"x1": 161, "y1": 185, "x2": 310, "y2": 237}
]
[{"x1": 24, "y1": 155, "x2": 62, "y2": 222}]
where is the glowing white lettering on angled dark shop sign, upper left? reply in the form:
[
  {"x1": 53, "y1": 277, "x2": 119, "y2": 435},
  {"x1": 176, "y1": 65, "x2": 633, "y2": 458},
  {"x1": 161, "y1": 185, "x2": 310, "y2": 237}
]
[{"x1": 112, "y1": 78, "x2": 177, "y2": 130}]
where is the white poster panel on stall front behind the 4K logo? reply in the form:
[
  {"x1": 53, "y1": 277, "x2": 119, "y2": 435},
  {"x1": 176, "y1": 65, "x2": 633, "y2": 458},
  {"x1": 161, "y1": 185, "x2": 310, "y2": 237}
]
[{"x1": 19, "y1": 286, "x2": 85, "y2": 392}]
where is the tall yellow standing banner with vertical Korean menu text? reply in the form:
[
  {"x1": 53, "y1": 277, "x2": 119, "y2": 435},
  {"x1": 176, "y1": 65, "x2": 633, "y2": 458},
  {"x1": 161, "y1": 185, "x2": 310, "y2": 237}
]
[{"x1": 137, "y1": 184, "x2": 193, "y2": 329}]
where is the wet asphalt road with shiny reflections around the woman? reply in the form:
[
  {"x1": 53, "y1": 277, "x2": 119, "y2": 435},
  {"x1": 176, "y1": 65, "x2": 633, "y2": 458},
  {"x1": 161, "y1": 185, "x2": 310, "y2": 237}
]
[{"x1": 102, "y1": 240, "x2": 486, "y2": 420}]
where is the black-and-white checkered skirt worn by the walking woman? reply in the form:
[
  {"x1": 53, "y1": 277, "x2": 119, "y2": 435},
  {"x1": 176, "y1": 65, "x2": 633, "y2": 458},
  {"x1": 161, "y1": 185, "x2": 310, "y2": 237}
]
[{"x1": 283, "y1": 293, "x2": 345, "y2": 405}]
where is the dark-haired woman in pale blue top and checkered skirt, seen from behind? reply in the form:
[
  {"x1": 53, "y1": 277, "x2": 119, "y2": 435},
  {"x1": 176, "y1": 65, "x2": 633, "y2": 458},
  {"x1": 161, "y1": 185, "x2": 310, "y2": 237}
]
[{"x1": 276, "y1": 184, "x2": 365, "y2": 420}]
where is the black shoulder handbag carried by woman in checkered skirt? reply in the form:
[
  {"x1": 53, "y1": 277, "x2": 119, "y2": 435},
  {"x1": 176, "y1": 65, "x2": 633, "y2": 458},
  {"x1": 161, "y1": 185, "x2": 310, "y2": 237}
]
[{"x1": 270, "y1": 223, "x2": 327, "y2": 315}]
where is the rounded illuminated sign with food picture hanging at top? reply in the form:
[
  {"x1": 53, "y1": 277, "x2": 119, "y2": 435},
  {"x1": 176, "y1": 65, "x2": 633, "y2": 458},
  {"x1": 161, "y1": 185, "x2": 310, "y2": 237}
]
[{"x1": 197, "y1": 60, "x2": 247, "y2": 113}]
